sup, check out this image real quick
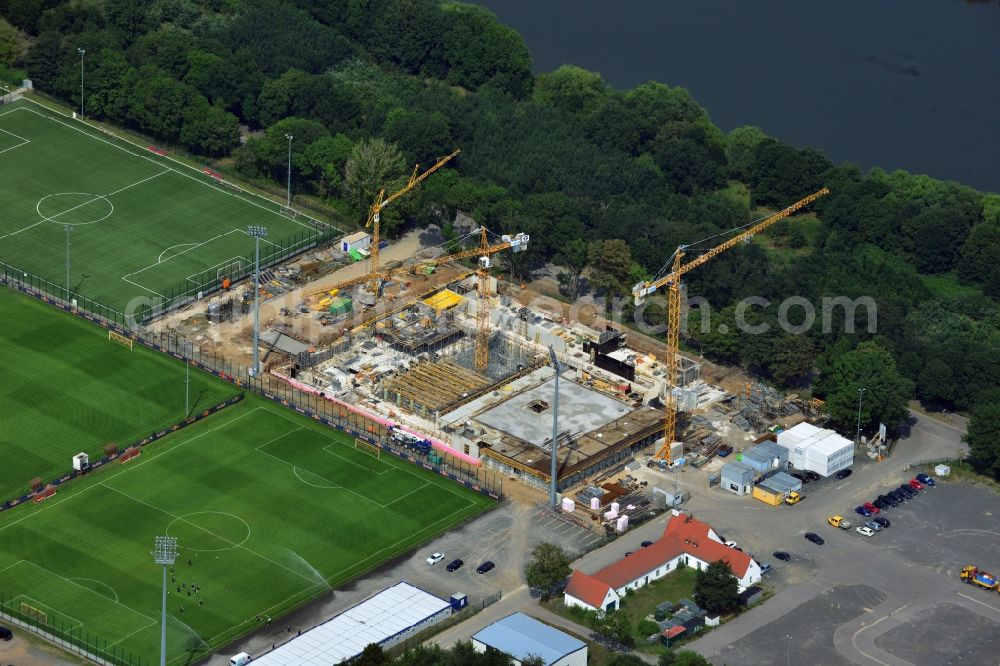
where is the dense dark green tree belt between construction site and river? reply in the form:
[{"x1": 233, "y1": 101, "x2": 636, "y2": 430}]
[{"x1": 0, "y1": 0, "x2": 1000, "y2": 452}]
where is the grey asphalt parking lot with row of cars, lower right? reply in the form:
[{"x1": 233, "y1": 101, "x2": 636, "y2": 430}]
[{"x1": 692, "y1": 468, "x2": 1000, "y2": 666}]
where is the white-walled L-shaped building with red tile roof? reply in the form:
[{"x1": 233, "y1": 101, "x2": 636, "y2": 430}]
[{"x1": 564, "y1": 510, "x2": 761, "y2": 610}]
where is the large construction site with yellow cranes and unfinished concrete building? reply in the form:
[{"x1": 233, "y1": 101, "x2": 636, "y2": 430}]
[{"x1": 146, "y1": 158, "x2": 825, "y2": 528}]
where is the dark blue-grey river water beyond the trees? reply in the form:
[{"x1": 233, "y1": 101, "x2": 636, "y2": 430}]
[{"x1": 477, "y1": 0, "x2": 1000, "y2": 192}]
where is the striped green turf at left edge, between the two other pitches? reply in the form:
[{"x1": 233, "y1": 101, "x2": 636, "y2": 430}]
[{"x1": 0, "y1": 287, "x2": 236, "y2": 502}]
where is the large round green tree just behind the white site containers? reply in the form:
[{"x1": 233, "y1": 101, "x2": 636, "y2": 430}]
[{"x1": 820, "y1": 342, "x2": 913, "y2": 431}]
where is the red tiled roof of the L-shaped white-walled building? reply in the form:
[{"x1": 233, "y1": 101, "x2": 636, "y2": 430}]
[{"x1": 566, "y1": 515, "x2": 751, "y2": 592}]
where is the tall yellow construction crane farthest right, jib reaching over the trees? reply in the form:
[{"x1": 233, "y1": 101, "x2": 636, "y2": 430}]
[{"x1": 632, "y1": 187, "x2": 830, "y2": 463}]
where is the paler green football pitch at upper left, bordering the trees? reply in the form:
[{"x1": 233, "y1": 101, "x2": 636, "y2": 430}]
[{"x1": 0, "y1": 100, "x2": 336, "y2": 311}]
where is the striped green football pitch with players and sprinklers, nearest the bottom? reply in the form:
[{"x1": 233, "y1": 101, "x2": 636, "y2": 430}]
[{"x1": 0, "y1": 386, "x2": 492, "y2": 664}]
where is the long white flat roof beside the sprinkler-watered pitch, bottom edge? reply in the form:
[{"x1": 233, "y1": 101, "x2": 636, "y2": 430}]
[{"x1": 254, "y1": 581, "x2": 451, "y2": 666}]
